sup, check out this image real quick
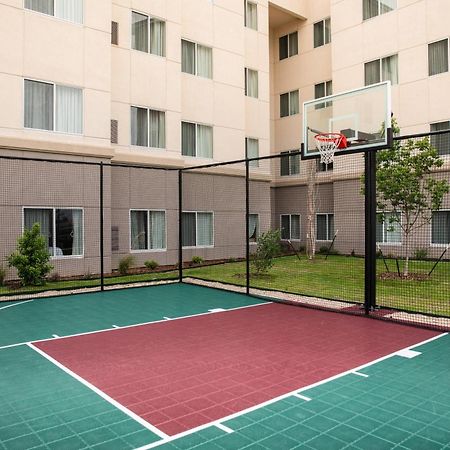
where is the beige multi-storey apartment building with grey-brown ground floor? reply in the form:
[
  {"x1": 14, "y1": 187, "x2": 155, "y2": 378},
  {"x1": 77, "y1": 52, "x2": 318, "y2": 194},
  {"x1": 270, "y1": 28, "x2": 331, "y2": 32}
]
[{"x1": 0, "y1": 0, "x2": 450, "y2": 275}]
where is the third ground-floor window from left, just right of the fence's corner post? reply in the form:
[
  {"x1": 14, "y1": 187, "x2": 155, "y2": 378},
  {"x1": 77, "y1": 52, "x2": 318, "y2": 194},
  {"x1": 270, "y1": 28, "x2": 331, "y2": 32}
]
[{"x1": 181, "y1": 212, "x2": 214, "y2": 247}]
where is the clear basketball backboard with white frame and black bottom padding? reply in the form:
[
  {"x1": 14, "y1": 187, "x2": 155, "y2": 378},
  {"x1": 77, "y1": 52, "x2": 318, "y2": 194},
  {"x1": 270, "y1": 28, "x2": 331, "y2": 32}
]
[{"x1": 302, "y1": 81, "x2": 391, "y2": 159}]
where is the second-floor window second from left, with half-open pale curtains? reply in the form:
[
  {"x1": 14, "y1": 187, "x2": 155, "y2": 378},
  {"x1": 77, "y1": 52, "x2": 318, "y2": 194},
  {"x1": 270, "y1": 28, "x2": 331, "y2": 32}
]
[{"x1": 131, "y1": 106, "x2": 166, "y2": 148}]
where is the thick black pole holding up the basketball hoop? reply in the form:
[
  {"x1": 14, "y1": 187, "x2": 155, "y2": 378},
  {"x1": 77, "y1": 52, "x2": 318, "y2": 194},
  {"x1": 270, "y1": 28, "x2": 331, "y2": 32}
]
[{"x1": 364, "y1": 151, "x2": 377, "y2": 314}]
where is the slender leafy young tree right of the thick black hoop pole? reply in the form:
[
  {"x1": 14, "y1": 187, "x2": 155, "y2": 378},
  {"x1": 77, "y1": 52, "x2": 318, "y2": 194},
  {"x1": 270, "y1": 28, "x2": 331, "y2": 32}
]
[{"x1": 376, "y1": 126, "x2": 449, "y2": 276}]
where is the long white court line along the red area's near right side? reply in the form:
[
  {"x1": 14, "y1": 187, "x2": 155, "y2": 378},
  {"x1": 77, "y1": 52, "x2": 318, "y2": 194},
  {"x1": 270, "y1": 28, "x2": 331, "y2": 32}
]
[{"x1": 135, "y1": 333, "x2": 448, "y2": 450}]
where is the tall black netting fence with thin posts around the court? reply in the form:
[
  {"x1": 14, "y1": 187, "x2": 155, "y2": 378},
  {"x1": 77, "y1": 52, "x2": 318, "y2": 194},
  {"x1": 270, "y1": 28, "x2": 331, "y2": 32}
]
[{"x1": 0, "y1": 132, "x2": 450, "y2": 329}]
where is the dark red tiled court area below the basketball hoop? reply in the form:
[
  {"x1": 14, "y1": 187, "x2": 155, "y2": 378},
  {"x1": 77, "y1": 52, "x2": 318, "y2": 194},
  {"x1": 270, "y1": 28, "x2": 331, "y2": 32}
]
[{"x1": 35, "y1": 304, "x2": 439, "y2": 435}]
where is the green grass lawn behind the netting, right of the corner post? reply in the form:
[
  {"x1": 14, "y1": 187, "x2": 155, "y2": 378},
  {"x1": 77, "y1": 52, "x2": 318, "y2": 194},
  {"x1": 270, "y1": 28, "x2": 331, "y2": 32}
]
[{"x1": 184, "y1": 255, "x2": 450, "y2": 316}]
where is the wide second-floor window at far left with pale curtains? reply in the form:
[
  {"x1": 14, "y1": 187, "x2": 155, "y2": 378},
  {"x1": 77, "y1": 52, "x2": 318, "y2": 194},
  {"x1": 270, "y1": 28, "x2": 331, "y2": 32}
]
[{"x1": 24, "y1": 80, "x2": 83, "y2": 134}]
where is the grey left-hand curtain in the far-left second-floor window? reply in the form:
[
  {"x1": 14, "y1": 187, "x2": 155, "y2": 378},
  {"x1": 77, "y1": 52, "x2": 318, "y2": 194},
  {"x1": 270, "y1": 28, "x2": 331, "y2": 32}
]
[{"x1": 24, "y1": 80, "x2": 53, "y2": 130}]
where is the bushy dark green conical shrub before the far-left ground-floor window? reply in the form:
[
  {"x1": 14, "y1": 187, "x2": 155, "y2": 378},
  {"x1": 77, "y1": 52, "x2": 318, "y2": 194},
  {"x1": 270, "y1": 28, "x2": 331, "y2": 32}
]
[{"x1": 7, "y1": 223, "x2": 53, "y2": 286}]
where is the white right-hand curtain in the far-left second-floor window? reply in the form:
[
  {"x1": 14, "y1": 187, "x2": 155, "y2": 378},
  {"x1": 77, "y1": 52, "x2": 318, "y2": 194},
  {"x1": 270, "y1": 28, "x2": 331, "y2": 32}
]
[{"x1": 55, "y1": 86, "x2": 83, "y2": 134}]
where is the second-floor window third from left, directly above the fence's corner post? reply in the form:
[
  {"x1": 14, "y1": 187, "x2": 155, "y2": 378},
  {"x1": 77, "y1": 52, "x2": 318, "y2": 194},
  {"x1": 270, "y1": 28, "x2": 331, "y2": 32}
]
[{"x1": 181, "y1": 122, "x2": 213, "y2": 158}]
